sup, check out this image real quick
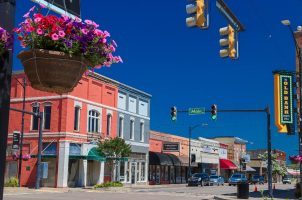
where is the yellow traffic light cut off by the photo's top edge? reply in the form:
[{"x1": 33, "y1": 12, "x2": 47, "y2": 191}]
[{"x1": 186, "y1": 0, "x2": 209, "y2": 29}]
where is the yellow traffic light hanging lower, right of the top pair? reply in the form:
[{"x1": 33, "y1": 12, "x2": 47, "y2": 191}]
[{"x1": 219, "y1": 25, "x2": 238, "y2": 59}]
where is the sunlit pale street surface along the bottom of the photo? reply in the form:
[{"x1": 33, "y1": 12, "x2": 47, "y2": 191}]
[{"x1": 4, "y1": 184, "x2": 294, "y2": 200}]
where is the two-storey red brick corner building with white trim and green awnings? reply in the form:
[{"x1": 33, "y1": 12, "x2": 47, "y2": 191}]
[{"x1": 6, "y1": 72, "x2": 118, "y2": 187}]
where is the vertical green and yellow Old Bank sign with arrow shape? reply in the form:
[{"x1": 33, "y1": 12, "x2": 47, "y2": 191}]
[{"x1": 274, "y1": 71, "x2": 294, "y2": 133}]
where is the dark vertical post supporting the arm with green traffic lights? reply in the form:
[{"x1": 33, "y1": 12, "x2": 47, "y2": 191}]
[{"x1": 265, "y1": 106, "x2": 273, "y2": 198}]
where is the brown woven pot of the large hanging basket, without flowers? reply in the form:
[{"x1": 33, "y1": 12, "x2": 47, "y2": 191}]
[{"x1": 18, "y1": 49, "x2": 87, "y2": 94}]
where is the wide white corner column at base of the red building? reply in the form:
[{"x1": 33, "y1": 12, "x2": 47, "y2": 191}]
[{"x1": 57, "y1": 141, "x2": 69, "y2": 187}]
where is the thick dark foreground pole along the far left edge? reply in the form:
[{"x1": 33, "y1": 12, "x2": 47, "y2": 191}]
[{"x1": 0, "y1": 0, "x2": 16, "y2": 200}]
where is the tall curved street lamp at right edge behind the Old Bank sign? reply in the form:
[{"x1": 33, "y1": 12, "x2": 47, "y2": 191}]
[{"x1": 281, "y1": 19, "x2": 302, "y2": 198}]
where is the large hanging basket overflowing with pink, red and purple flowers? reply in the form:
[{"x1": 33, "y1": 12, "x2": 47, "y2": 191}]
[{"x1": 14, "y1": 7, "x2": 122, "y2": 94}]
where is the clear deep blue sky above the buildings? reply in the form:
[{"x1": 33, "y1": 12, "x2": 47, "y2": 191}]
[{"x1": 14, "y1": 0, "x2": 302, "y2": 159}]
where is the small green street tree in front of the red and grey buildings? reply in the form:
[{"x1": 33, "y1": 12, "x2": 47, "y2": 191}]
[{"x1": 98, "y1": 137, "x2": 131, "y2": 181}]
